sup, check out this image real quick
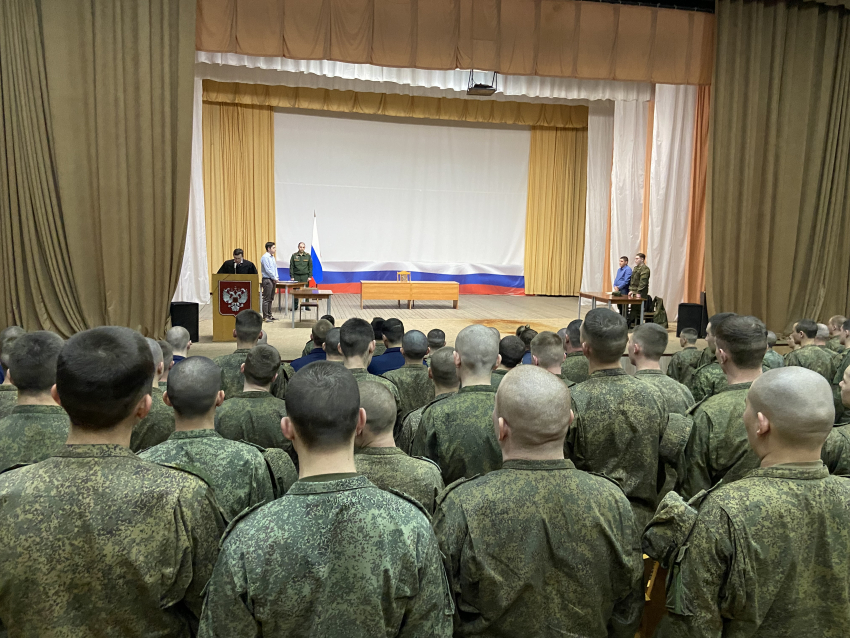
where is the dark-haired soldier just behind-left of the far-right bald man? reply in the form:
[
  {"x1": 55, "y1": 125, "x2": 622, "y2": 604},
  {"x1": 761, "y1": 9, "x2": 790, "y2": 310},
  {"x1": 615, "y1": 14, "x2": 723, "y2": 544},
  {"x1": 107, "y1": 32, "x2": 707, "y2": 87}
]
[{"x1": 676, "y1": 315, "x2": 767, "y2": 499}]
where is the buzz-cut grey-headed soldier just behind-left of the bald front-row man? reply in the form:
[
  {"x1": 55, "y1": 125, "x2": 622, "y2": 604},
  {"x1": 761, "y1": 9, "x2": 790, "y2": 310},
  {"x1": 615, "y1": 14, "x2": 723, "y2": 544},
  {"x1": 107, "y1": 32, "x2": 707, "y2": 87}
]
[{"x1": 411, "y1": 324, "x2": 502, "y2": 485}]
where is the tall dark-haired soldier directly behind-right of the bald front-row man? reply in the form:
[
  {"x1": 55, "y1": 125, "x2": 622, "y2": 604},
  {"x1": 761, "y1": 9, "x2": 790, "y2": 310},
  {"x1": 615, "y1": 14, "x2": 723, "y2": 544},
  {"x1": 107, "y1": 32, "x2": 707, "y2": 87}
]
[{"x1": 565, "y1": 308, "x2": 667, "y2": 529}]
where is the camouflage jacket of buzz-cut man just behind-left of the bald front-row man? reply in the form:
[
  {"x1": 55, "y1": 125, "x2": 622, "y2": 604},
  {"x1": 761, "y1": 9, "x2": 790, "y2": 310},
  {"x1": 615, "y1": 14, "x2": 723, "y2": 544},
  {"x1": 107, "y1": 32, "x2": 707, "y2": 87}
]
[{"x1": 411, "y1": 385, "x2": 502, "y2": 485}]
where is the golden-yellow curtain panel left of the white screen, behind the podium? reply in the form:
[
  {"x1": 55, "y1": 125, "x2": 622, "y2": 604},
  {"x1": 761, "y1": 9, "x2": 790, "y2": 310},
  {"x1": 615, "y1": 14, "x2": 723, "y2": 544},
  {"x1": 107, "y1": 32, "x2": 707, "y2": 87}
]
[{"x1": 203, "y1": 102, "x2": 276, "y2": 272}]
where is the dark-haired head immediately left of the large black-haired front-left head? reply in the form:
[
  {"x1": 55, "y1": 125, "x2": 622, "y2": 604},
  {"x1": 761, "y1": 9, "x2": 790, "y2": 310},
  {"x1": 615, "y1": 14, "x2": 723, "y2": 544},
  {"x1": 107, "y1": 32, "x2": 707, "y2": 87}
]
[{"x1": 7, "y1": 330, "x2": 65, "y2": 395}]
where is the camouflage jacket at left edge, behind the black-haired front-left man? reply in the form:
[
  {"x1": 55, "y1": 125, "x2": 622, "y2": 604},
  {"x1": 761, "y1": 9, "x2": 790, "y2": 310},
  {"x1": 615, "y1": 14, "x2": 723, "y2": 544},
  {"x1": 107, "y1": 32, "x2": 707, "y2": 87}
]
[{"x1": 0, "y1": 405, "x2": 71, "y2": 472}]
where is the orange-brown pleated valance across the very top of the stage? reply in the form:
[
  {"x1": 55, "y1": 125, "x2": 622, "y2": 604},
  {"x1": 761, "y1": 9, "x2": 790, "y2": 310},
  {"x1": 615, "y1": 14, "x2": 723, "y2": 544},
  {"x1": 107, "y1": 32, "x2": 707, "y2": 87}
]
[{"x1": 196, "y1": 0, "x2": 714, "y2": 84}]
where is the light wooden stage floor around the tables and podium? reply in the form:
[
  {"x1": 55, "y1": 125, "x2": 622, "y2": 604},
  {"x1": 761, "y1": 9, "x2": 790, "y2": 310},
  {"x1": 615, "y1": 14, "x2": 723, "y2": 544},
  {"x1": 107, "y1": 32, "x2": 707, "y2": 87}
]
[{"x1": 191, "y1": 294, "x2": 688, "y2": 360}]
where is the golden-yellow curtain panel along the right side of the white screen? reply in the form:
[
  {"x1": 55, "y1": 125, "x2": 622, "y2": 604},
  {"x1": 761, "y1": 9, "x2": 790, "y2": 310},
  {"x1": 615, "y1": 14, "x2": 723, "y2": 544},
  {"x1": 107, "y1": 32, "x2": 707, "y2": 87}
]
[{"x1": 525, "y1": 127, "x2": 587, "y2": 295}]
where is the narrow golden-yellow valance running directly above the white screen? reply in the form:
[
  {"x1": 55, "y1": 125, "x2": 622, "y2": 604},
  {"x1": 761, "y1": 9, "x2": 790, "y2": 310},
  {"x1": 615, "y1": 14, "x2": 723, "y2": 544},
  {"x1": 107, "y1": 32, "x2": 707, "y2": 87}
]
[{"x1": 204, "y1": 80, "x2": 587, "y2": 129}]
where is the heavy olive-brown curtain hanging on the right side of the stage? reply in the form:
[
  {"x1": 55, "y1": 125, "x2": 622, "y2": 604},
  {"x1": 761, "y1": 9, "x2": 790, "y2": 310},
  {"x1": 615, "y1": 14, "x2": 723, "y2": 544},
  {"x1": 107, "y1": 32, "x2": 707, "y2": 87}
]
[{"x1": 706, "y1": 0, "x2": 850, "y2": 332}]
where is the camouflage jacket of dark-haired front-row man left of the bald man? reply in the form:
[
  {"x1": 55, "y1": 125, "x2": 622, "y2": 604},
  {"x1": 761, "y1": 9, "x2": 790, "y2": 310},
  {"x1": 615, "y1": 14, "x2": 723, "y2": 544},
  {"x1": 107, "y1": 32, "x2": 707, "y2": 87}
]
[{"x1": 200, "y1": 474, "x2": 453, "y2": 638}]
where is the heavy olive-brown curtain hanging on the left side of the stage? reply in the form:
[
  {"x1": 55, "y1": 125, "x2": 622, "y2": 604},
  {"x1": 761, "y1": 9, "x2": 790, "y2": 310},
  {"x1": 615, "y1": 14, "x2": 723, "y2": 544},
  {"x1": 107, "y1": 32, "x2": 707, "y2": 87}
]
[{"x1": 0, "y1": 0, "x2": 195, "y2": 336}]
